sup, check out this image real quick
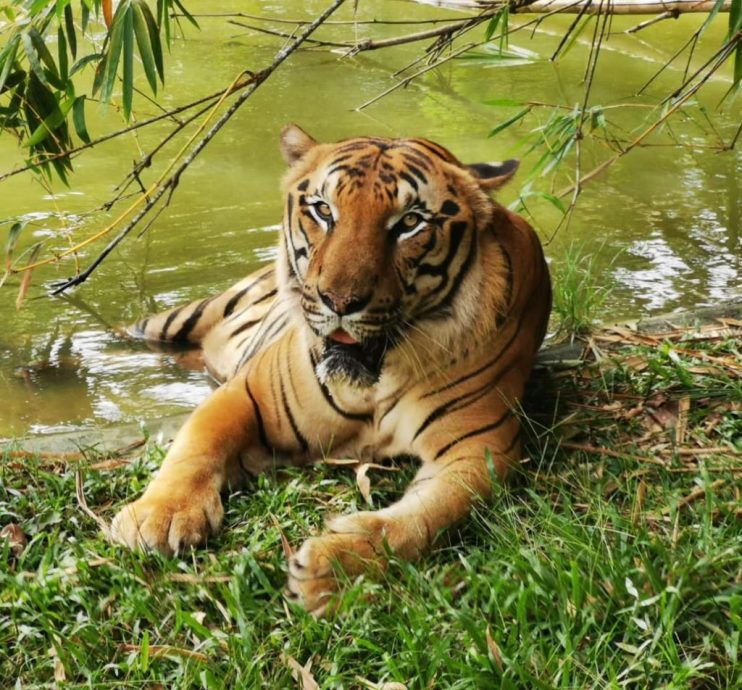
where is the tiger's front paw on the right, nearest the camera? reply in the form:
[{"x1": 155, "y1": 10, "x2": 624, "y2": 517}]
[{"x1": 286, "y1": 512, "x2": 387, "y2": 617}]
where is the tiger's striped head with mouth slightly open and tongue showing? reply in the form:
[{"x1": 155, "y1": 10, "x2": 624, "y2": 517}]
[{"x1": 279, "y1": 125, "x2": 518, "y2": 387}]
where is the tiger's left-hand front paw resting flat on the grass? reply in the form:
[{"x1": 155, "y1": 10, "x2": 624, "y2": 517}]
[{"x1": 111, "y1": 486, "x2": 224, "y2": 556}]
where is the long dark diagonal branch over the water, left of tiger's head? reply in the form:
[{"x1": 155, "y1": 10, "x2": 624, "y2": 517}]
[{"x1": 52, "y1": 0, "x2": 345, "y2": 295}]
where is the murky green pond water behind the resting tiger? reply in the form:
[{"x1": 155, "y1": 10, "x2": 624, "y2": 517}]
[{"x1": 0, "y1": 0, "x2": 742, "y2": 437}]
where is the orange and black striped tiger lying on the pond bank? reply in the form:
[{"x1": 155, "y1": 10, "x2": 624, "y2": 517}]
[{"x1": 111, "y1": 124, "x2": 551, "y2": 616}]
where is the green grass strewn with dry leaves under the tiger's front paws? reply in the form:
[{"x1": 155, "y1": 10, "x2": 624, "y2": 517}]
[{"x1": 0, "y1": 330, "x2": 742, "y2": 689}]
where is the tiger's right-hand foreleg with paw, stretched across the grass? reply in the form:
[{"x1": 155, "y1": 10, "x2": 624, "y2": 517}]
[{"x1": 288, "y1": 419, "x2": 520, "y2": 616}]
